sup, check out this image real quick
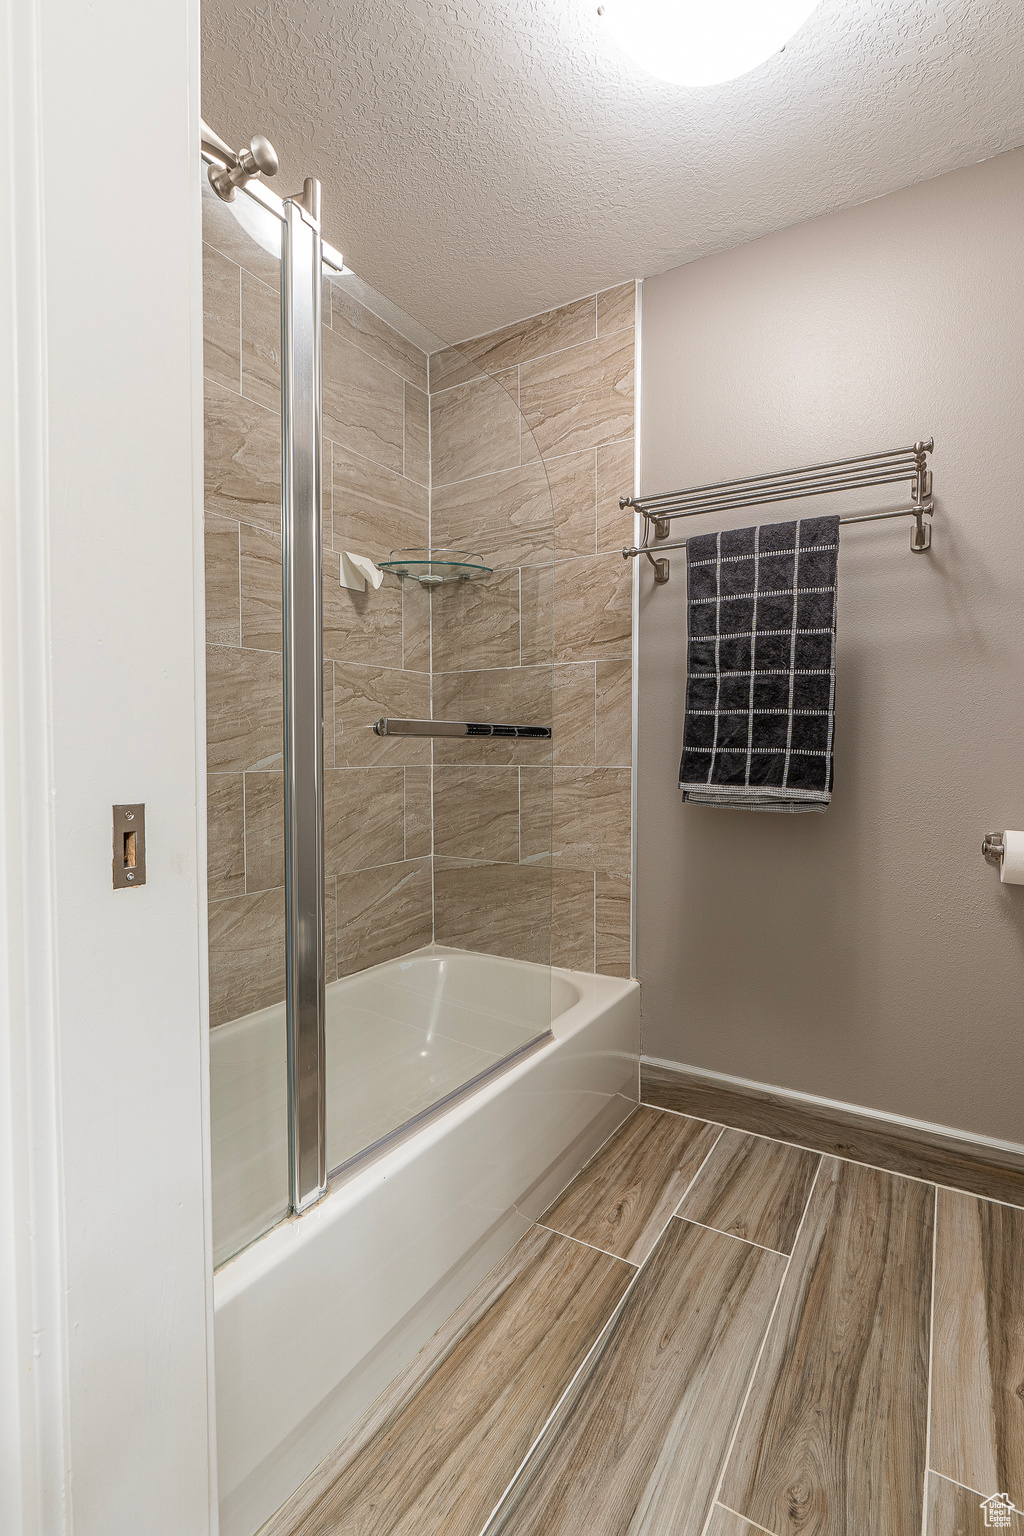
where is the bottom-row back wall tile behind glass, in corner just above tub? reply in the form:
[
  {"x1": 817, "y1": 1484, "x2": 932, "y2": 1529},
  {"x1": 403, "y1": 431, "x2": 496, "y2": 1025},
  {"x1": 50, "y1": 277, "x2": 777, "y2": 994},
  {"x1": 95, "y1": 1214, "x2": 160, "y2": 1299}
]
[{"x1": 434, "y1": 859, "x2": 551, "y2": 965}]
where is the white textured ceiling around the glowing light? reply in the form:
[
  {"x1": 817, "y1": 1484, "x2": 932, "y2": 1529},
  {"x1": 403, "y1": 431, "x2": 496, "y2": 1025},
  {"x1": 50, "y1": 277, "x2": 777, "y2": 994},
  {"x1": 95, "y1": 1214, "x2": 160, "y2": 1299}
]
[{"x1": 203, "y1": 0, "x2": 1024, "y2": 339}]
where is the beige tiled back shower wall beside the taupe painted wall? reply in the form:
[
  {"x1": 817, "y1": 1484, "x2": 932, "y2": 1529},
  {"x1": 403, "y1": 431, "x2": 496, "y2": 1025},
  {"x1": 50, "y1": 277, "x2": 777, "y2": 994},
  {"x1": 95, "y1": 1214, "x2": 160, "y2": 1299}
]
[{"x1": 430, "y1": 283, "x2": 636, "y2": 975}]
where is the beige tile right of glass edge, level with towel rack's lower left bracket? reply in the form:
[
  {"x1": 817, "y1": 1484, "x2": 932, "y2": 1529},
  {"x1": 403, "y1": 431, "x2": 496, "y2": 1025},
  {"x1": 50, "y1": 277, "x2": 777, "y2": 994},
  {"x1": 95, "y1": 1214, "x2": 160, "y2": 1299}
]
[{"x1": 554, "y1": 554, "x2": 633, "y2": 662}]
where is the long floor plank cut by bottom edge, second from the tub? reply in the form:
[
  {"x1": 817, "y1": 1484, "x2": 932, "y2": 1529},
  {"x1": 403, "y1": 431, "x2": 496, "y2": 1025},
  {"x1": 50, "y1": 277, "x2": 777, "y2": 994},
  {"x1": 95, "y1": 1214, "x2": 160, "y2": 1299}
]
[{"x1": 491, "y1": 1218, "x2": 785, "y2": 1536}]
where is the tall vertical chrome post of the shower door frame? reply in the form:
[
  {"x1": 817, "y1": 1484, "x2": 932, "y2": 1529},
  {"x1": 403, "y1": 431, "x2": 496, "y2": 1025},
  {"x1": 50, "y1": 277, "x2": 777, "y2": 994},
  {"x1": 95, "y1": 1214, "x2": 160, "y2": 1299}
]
[{"x1": 281, "y1": 181, "x2": 327, "y2": 1212}]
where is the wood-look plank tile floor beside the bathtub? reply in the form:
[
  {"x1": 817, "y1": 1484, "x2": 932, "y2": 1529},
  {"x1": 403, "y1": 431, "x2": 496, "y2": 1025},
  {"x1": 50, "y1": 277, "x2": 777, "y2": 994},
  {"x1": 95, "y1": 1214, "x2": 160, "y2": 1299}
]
[{"x1": 263, "y1": 1104, "x2": 1024, "y2": 1536}]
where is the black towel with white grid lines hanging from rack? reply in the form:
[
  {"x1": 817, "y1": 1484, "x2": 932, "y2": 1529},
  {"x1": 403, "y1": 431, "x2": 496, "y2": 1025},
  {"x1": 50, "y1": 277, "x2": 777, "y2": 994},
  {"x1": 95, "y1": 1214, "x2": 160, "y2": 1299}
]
[{"x1": 679, "y1": 518, "x2": 840, "y2": 811}]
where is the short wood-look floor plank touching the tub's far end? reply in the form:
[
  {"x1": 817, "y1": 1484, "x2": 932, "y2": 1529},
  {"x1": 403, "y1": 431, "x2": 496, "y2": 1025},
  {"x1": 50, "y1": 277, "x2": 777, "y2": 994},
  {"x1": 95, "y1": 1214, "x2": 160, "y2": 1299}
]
[{"x1": 540, "y1": 1104, "x2": 722, "y2": 1264}]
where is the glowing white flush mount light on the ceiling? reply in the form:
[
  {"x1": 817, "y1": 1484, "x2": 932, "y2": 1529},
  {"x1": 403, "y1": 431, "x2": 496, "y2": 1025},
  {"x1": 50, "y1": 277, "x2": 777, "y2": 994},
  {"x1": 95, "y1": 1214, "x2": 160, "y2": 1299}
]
[{"x1": 597, "y1": 0, "x2": 818, "y2": 86}]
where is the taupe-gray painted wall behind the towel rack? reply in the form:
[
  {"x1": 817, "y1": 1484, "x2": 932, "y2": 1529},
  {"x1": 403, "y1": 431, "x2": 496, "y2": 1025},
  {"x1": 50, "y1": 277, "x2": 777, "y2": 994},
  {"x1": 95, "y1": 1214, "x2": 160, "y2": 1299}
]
[{"x1": 637, "y1": 151, "x2": 1024, "y2": 1141}]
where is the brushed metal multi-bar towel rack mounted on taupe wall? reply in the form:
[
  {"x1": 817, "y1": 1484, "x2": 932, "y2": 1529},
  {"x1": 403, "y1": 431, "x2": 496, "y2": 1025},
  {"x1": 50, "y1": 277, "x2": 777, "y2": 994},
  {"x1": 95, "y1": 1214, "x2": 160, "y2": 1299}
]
[{"x1": 619, "y1": 438, "x2": 935, "y2": 582}]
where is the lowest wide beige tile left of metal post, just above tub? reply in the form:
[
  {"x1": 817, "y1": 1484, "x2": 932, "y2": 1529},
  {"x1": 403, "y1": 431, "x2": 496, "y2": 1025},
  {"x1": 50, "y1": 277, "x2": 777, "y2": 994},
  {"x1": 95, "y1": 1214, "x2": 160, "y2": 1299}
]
[{"x1": 209, "y1": 891, "x2": 284, "y2": 1025}]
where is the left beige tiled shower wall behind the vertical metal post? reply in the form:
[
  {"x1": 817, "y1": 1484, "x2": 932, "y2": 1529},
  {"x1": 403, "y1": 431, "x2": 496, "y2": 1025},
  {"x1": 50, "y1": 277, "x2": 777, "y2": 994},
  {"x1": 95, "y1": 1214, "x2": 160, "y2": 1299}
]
[{"x1": 203, "y1": 200, "x2": 431, "y2": 1025}]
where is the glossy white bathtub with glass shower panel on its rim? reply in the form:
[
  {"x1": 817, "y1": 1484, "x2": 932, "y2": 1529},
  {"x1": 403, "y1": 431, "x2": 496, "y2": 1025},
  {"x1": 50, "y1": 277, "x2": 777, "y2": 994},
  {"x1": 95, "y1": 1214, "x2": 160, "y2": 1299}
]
[{"x1": 212, "y1": 946, "x2": 640, "y2": 1536}]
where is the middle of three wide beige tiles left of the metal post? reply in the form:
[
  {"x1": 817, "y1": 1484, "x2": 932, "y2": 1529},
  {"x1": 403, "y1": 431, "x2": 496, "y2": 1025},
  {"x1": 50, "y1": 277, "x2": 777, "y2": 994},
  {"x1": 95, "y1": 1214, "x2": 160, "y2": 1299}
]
[{"x1": 206, "y1": 645, "x2": 282, "y2": 773}]
